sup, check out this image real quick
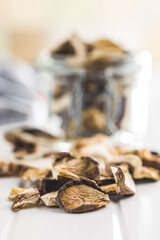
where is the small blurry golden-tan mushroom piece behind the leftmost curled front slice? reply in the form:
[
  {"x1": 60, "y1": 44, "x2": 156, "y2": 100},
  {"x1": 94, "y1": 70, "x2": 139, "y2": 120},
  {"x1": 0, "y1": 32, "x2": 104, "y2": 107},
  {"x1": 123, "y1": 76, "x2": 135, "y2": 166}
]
[{"x1": 22, "y1": 168, "x2": 52, "y2": 182}]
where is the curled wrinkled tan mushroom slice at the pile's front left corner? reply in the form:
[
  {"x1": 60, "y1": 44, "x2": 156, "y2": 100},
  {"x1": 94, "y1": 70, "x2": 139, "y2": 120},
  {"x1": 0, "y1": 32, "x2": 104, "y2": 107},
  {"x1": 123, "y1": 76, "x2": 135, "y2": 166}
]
[{"x1": 8, "y1": 188, "x2": 40, "y2": 210}]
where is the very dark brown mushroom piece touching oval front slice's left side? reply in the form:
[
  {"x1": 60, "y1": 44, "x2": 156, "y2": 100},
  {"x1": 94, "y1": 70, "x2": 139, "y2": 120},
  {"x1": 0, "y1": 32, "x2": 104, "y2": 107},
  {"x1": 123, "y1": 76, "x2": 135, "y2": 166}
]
[{"x1": 36, "y1": 178, "x2": 64, "y2": 195}]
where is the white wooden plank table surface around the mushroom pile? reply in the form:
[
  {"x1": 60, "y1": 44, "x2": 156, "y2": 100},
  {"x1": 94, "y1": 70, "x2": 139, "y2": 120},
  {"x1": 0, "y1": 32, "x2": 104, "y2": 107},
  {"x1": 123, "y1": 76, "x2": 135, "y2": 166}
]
[{"x1": 0, "y1": 65, "x2": 160, "y2": 240}]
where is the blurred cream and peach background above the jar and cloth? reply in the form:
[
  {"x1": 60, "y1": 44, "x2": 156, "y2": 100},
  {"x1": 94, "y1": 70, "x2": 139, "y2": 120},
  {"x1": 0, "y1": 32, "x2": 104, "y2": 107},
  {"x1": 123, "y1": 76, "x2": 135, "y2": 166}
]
[{"x1": 0, "y1": 0, "x2": 160, "y2": 61}]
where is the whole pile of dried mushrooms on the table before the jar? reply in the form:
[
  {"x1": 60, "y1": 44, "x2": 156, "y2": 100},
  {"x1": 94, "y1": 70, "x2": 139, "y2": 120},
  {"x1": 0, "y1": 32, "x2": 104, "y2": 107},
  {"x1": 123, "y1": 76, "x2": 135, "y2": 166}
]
[{"x1": 0, "y1": 127, "x2": 160, "y2": 213}]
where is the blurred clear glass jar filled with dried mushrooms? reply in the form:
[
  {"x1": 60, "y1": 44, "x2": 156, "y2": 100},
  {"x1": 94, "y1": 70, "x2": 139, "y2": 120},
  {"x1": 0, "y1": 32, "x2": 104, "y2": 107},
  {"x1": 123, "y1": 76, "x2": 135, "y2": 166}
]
[{"x1": 39, "y1": 49, "x2": 152, "y2": 142}]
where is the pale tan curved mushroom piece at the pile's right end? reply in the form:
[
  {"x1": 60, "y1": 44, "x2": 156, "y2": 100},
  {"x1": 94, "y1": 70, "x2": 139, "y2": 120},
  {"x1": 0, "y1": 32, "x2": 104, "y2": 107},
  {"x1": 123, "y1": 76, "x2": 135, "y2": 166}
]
[{"x1": 110, "y1": 154, "x2": 159, "y2": 181}]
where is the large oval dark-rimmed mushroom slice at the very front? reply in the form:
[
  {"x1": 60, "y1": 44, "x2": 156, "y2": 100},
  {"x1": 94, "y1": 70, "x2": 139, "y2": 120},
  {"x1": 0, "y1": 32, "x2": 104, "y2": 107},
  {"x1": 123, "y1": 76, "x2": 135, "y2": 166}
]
[{"x1": 57, "y1": 178, "x2": 110, "y2": 213}]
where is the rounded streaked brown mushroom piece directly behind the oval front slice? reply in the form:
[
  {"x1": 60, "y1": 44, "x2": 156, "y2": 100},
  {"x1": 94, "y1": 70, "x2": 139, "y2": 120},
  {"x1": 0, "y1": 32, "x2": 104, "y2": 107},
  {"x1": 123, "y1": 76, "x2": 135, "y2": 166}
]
[{"x1": 53, "y1": 157, "x2": 100, "y2": 182}]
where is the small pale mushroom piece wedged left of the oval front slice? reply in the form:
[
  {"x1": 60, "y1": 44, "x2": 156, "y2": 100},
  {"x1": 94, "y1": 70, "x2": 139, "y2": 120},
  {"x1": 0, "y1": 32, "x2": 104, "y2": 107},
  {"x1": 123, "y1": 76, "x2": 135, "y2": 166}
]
[{"x1": 41, "y1": 191, "x2": 58, "y2": 207}]
